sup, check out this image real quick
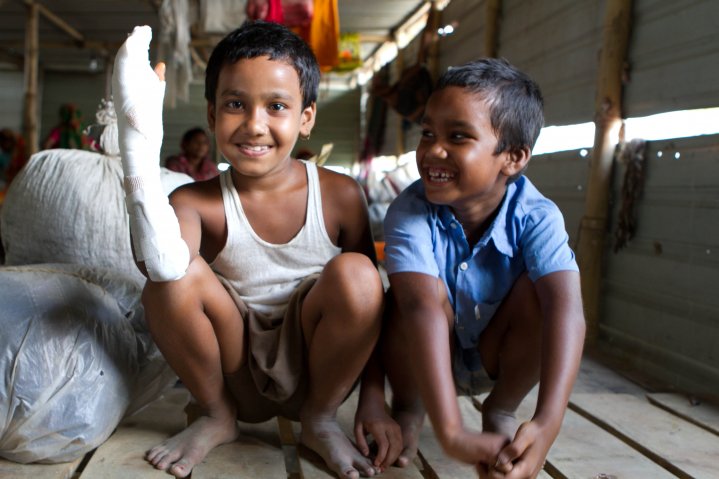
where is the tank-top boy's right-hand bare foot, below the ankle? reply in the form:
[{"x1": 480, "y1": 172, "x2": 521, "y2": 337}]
[{"x1": 300, "y1": 417, "x2": 377, "y2": 479}]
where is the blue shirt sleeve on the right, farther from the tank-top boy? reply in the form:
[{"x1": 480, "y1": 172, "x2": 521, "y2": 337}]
[{"x1": 521, "y1": 204, "x2": 579, "y2": 281}]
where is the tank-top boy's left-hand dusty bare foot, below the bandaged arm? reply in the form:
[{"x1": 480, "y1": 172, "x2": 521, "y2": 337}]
[{"x1": 145, "y1": 416, "x2": 239, "y2": 477}]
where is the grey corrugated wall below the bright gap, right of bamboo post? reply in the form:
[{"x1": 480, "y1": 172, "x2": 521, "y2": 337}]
[{"x1": 599, "y1": 136, "x2": 719, "y2": 395}]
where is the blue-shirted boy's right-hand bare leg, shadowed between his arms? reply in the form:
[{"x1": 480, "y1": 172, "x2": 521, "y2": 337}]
[{"x1": 479, "y1": 273, "x2": 542, "y2": 440}]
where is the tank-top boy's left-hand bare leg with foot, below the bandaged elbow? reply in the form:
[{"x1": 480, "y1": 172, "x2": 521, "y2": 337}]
[{"x1": 143, "y1": 256, "x2": 245, "y2": 477}]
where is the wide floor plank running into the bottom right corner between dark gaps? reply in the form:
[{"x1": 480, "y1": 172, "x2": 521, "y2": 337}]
[{"x1": 571, "y1": 393, "x2": 719, "y2": 478}]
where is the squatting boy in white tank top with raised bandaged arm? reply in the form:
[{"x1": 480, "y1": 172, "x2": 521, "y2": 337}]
[{"x1": 113, "y1": 22, "x2": 401, "y2": 478}]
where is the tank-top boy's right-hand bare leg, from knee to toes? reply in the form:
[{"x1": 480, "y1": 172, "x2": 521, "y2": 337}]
[{"x1": 300, "y1": 253, "x2": 382, "y2": 478}]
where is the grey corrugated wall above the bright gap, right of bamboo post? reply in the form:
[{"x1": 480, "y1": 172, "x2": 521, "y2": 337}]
[{"x1": 624, "y1": 0, "x2": 719, "y2": 117}]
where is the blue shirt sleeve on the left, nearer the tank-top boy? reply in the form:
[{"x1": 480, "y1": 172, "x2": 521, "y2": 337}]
[{"x1": 384, "y1": 187, "x2": 439, "y2": 277}]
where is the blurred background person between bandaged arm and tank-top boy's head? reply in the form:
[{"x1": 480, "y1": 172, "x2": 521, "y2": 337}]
[{"x1": 165, "y1": 127, "x2": 220, "y2": 181}]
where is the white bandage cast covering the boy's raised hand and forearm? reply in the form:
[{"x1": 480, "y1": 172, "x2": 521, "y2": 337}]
[{"x1": 112, "y1": 26, "x2": 190, "y2": 281}]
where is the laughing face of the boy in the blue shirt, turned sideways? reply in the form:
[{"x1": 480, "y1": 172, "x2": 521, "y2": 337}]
[{"x1": 417, "y1": 86, "x2": 528, "y2": 214}]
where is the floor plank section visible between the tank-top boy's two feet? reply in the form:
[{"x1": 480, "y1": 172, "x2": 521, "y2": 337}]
[{"x1": 192, "y1": 419, "x2": 287, "y2": 479}]
